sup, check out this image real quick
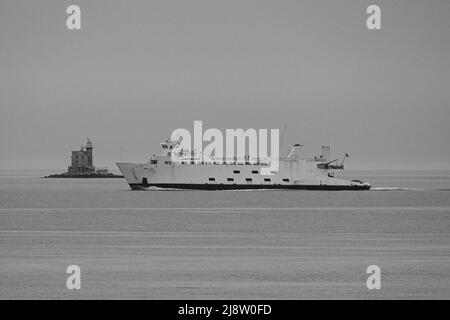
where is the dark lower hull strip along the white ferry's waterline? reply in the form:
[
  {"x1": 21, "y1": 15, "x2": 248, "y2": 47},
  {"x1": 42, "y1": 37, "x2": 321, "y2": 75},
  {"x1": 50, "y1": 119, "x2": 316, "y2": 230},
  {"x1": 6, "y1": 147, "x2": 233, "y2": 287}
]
[{"x1": 130, "y1": 183, "x2": 370, "y2": 191}]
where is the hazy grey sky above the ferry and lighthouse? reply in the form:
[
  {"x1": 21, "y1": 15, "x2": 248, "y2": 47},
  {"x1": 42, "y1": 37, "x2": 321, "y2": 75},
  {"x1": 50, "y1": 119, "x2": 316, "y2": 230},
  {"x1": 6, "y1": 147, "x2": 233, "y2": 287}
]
[{"x1": 0, "y1": 0, "x2": 450, "y2": 169}]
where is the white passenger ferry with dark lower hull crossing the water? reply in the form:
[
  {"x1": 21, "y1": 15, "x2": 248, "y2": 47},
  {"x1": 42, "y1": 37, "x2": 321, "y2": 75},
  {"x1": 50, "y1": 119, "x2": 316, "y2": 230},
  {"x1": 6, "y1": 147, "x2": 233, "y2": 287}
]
[{"x1": 117, "y1": 139, "x2": 370, "y2": 190}]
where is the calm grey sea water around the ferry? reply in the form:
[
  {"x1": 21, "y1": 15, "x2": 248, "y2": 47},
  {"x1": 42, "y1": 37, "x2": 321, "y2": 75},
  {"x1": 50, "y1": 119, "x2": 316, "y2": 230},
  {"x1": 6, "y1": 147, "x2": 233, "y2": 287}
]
[{"x1": 0, "y1": 171, "x2": 450, "y2": 299}]
